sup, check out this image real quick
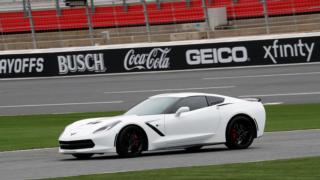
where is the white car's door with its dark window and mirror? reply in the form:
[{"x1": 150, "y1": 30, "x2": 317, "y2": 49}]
[{"x1": 165, "y1": 96, "x2": 220, "y2": 146}]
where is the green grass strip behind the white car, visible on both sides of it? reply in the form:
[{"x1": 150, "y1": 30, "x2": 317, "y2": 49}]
[{"x1": 0, "y1": 104, "x2": 320, "y2": 151}]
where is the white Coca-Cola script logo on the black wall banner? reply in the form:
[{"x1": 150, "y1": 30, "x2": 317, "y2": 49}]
[{"x1": 124, "y1": 48, "x2": 171, "y2": 71}]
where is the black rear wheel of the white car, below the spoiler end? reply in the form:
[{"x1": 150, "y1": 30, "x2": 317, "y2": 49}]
[{"x1": 226, "y1": 116, "x2": 256, "y2": 149}]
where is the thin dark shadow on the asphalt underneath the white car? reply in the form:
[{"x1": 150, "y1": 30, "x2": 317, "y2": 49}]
[{"x1": 61, "y1": 147, "x2": 253, "y2": 161}]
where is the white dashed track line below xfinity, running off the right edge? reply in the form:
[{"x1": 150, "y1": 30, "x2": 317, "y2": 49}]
[{"x1": 203, "y1": 72, "x2": 320, "y2": 80}]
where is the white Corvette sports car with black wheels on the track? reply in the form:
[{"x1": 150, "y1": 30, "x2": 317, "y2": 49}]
[{"x1": 59, "y1": 93, "x2": 266, "y2": 158}]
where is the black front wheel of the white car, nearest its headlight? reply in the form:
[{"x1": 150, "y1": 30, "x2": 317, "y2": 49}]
[{"x1": 116, "y1": 125, "x2": 147, "y2": 157}]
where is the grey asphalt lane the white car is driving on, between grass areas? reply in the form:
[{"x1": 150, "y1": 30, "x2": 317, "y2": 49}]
[{"x1": 0, "y1": 130, "x2": 320, "y2": 179}]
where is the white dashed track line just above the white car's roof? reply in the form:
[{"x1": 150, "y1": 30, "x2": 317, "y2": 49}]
[{"x1": 104, "y1": 86, "x2": 236, "y2": 94}]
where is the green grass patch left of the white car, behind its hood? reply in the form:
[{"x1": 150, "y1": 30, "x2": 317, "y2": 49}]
[{"x1": 0, "y1": 112, "x2": 122, "y2": 151}]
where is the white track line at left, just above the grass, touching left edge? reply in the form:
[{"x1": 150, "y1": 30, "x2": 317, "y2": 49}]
[{"x1": 0, "y1": 101, "x2": 123, "y2": 108}]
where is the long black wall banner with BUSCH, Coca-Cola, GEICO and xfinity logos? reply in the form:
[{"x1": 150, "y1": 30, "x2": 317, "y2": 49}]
[{"x1": 0, "y1": 36, "x2": 320, "y2": 78}]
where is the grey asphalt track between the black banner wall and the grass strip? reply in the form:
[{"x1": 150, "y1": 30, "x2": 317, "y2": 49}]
[{"x1": 0, "y1": 63, "x2": 320, "y2": 115}]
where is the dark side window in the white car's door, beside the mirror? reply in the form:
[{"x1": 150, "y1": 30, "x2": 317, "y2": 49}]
[{"x1": 169, "y1": 96, "x2": 208, "y2": 113}]
